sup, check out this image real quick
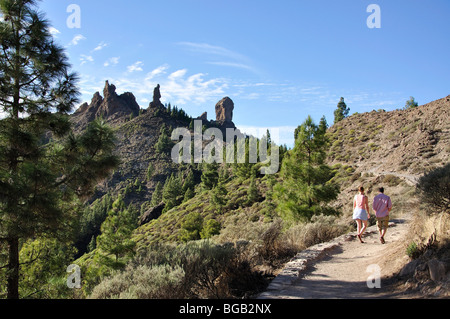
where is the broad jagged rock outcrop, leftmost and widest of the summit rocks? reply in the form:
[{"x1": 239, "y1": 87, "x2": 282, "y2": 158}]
[{"x1": 72, "y1": 81, "x2": 140, "y2": 131}]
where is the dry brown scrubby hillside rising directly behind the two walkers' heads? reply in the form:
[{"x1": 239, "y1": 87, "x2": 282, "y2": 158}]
[{"x1": 328, "y1": 96, "x2": 450, "y2": 211}]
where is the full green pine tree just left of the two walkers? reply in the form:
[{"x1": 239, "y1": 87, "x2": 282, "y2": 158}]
[{"x1": 274, "y1": 116, "x2": 339, "y2": 220}]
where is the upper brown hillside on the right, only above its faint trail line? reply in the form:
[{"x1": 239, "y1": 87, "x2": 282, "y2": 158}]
[{"x1": 329, "y1": 96, "x2": 450, "y2": 181}]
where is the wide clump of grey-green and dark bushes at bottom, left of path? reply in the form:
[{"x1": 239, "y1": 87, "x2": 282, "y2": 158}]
[{"x1": 91, "y1": 240, "x2": 267, "y2": 299}]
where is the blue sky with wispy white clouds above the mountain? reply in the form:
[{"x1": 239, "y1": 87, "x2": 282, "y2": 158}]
[{"x1": 39, "y1": 0, "x2": 450, "y2": 145}]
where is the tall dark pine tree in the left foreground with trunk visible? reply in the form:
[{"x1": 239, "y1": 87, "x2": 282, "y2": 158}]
[{"x1": 0, "y1": 0, "x2": 118, "y2": 299}]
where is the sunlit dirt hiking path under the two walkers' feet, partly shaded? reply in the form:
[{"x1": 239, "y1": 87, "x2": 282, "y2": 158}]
[{"x1": 259, "y1": 219, "x2": 408, "y2": 299}]
